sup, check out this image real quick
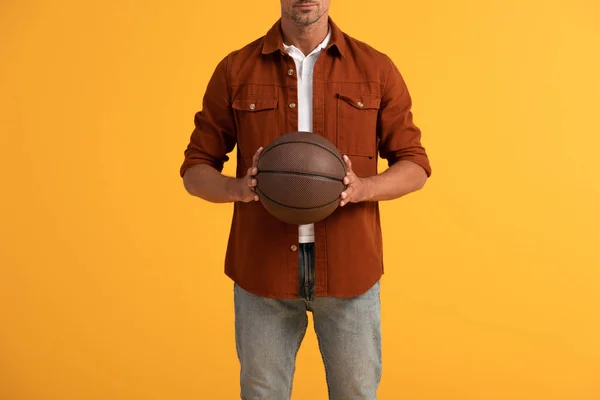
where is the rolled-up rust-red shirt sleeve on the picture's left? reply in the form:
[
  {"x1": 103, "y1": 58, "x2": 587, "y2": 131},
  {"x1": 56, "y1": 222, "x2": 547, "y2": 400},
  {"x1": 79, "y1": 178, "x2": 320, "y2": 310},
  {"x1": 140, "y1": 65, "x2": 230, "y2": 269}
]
[{"x1": 179, "y1": 56, "x2": 236, "y2": 177}]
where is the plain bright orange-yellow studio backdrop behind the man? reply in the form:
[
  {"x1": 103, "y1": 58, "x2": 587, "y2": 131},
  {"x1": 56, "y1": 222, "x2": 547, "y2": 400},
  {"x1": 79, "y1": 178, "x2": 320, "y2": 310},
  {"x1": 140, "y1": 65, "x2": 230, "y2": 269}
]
[{"x1": 0, "y1": 0, "x2": 600, "y2": 400}]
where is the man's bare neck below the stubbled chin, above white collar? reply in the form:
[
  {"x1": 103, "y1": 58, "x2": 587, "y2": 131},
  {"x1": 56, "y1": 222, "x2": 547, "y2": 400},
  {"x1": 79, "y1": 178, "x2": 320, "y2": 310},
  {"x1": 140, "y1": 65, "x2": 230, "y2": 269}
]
[{"x1": 281, "y1": 14, "x2": 329, "y2": 54}]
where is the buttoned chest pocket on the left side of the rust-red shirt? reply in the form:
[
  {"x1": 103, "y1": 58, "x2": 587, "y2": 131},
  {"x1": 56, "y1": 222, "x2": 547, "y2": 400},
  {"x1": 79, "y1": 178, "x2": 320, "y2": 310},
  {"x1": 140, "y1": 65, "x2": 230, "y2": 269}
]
[{"x1": 232, "y1": 95, "x2": 278, "y2": 157}]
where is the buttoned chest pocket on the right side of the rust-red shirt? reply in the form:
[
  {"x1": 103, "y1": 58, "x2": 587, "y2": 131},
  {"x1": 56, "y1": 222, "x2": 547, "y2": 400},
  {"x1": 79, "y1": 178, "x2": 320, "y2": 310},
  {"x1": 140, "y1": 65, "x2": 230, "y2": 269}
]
[{"x1": 336, "y1": 93, "x2": 381, "y2": 157}]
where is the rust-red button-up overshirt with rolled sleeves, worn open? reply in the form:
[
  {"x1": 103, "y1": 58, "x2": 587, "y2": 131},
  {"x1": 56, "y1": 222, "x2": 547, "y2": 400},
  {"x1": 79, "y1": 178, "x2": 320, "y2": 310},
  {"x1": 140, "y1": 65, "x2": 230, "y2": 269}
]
[{"x1": 180, "y1": 18, "x2": 431, "y2": 298}]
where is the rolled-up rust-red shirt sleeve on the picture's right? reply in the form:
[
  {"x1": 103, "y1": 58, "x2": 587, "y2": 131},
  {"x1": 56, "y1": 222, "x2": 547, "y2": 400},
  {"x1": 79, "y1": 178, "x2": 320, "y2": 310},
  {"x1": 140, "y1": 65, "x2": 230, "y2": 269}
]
[{"x1": 377, "y1": 57, "x2": 431, "y2": 176}]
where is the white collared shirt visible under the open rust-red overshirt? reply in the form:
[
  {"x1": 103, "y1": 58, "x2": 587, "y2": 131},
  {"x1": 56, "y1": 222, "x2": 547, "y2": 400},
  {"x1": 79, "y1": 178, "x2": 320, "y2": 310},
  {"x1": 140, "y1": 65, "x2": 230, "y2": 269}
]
[{"x1": 283, "y1": 28, "x2": 331, "y2": 243}]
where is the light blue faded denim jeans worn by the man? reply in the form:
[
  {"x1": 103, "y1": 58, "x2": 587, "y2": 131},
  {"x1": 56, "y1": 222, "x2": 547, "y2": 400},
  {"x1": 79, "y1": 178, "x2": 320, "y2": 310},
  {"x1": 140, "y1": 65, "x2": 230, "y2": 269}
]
[{"x1": 234, "y1": 244, "x2": 382, "y2": 400}]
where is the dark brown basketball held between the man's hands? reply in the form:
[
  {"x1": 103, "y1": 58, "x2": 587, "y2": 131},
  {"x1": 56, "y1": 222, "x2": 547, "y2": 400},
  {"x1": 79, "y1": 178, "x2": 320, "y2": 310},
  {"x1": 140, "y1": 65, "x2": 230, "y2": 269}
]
[{"x1": 256, "y1": 132, "x2": 346, "y2": 225}]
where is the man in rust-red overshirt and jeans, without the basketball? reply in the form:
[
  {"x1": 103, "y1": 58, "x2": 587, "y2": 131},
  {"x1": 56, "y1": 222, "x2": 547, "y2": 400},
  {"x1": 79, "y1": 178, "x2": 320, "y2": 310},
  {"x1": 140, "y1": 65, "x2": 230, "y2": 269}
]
[{"x1": 180, "y1": 0, "x2": 431, "y2": 400}]
